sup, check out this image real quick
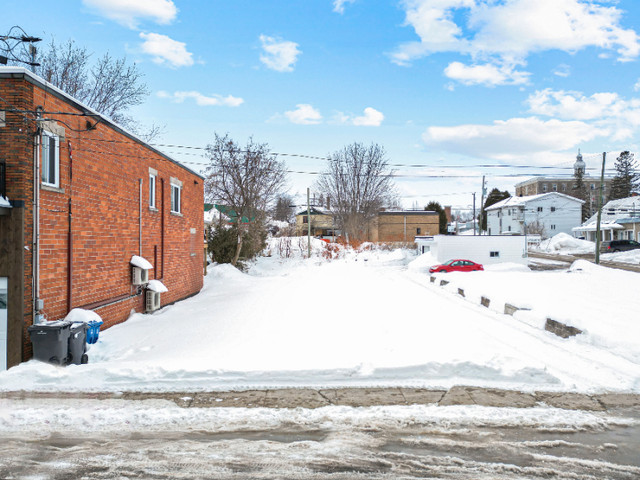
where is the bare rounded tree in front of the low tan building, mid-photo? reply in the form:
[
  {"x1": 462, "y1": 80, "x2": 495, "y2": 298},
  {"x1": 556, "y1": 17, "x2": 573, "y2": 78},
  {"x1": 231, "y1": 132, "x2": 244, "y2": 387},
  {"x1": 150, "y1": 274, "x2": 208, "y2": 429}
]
[{"x1": 317, "y1": 143, "x2": 396, "y2": 240}]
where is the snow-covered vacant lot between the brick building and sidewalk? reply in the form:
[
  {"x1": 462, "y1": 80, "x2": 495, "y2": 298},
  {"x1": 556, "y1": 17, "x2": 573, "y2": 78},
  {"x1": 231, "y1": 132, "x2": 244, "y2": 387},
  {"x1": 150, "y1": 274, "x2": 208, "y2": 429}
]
[{"x1": 0, "y1": 240, "x2": 640, "y2": 393}]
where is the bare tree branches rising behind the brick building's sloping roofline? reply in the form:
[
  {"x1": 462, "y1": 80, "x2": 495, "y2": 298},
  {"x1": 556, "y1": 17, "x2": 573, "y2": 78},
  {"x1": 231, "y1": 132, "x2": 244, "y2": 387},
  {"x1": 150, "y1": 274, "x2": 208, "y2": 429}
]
[{"x1": 12, "y1": 39, "x2": 162, "y2": 142}]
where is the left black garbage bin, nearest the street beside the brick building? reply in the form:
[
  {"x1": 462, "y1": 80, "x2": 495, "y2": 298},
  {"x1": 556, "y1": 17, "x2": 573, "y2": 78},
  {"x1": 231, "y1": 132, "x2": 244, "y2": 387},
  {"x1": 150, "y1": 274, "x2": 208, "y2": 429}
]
[{"x1": 27, "y1": 320, "x2": 71, "y2": 365}]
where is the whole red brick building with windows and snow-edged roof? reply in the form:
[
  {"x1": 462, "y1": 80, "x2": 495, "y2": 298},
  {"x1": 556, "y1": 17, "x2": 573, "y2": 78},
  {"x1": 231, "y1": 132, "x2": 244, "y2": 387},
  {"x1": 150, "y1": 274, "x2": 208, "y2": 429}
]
[{"x1": 0, "y1": 67, "x2": 204, "y2": 368}]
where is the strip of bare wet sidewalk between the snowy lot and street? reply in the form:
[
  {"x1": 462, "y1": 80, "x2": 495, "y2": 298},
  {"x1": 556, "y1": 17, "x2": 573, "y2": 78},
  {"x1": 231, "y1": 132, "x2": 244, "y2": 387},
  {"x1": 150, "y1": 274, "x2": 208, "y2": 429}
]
[{"x1": 5, "y1": 386, "x2": 640, "y2": 411}]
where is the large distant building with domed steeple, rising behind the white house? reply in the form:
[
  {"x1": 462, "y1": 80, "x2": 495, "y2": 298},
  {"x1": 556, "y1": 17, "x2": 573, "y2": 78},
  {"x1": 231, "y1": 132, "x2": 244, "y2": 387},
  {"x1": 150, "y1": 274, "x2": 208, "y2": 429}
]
[{"x1": 515, "y1": 152, "x2": 613, "y2": 214}]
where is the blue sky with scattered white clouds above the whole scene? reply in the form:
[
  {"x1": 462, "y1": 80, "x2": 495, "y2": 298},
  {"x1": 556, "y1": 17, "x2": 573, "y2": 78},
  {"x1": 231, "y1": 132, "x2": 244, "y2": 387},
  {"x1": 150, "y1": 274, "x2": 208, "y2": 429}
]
[{"x1": 0, "y1": 0, "x2": 640, "y2": 207}]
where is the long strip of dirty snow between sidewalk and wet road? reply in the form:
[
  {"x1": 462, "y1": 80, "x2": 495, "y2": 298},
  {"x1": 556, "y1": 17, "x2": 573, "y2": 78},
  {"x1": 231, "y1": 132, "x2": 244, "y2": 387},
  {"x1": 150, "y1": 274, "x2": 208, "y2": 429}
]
[{"x1": 0, "y1": 399, "x2": 637, "y2": 438}]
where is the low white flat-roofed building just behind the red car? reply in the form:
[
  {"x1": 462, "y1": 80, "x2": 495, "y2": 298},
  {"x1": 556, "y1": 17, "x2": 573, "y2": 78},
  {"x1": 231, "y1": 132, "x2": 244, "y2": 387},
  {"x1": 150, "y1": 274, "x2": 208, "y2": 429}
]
[{"x1": 431, "y1": 235, "x2": 528, "y2": 265}]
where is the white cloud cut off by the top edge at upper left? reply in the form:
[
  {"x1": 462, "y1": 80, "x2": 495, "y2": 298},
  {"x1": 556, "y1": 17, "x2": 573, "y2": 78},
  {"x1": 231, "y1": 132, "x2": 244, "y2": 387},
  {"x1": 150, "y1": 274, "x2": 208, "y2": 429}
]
[{"x1": 82, "y1": 0, "x2": 178, "y2": 28}]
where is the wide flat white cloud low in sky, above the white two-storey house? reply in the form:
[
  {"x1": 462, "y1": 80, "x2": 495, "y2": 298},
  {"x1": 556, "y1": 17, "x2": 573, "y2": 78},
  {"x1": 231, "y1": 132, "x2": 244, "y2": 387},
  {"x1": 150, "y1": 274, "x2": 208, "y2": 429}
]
[{"x1": 422, "y1": 117, "x2": 610, "y2": 161}]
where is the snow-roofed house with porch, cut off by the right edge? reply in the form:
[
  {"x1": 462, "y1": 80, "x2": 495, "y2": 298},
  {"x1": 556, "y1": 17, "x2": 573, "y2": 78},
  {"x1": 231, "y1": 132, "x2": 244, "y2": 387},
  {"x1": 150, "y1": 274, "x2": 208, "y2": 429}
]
[{"x1": 573, "y1": 196, "x2": 640, "y2": 242}]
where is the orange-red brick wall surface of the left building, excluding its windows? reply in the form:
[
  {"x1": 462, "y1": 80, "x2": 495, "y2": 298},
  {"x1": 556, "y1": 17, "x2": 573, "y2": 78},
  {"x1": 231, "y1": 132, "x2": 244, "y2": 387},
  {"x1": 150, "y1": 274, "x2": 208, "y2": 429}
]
[{"x1": 0, "y1": 74, "x2": 204, "y2": 355}]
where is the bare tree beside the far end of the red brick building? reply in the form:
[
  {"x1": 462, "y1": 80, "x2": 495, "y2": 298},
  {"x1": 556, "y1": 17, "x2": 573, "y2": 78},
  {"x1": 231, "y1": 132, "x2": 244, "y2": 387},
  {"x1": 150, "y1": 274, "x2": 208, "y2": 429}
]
[{"x1": 205, "y1": 134, "x2": 286, "y2": 265}]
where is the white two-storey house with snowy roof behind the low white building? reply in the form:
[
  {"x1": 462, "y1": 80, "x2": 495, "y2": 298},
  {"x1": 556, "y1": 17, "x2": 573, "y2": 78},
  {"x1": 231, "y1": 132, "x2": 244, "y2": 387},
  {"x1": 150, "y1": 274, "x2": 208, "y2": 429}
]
[{"x1": 487, "y1": 192, "x2": 584, "y2": 237}]
